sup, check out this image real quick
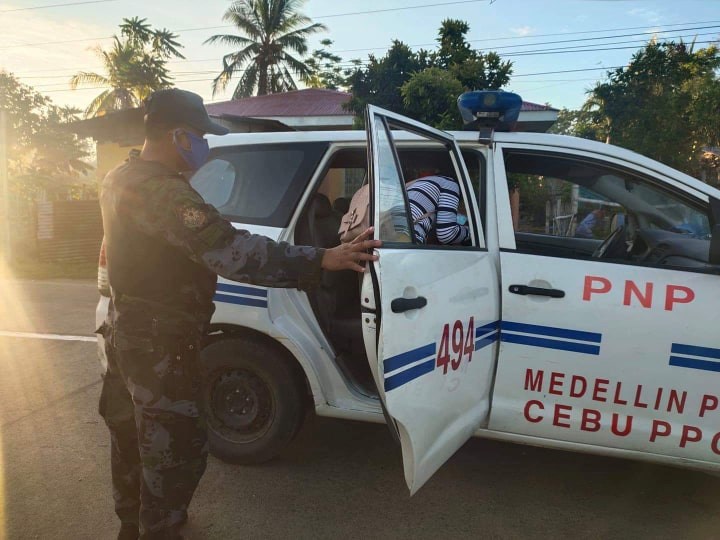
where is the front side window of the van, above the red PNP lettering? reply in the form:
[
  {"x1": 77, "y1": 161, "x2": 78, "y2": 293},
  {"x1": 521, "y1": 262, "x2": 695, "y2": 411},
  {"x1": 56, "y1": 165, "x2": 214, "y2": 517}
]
[{"x1": 504, "y1": 150, "x2": 711, "y2": 267}]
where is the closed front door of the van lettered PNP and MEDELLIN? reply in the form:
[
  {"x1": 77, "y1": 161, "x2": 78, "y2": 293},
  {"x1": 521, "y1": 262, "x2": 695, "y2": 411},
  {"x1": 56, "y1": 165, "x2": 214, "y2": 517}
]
[{"x1": 490, "y1": 138, "x2": 720, "y2": 464}]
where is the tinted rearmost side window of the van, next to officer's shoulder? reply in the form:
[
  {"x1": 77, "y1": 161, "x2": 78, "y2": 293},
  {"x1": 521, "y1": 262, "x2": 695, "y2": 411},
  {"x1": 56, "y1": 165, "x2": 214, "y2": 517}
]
[{"x1": 190, "y1": 143, "x2": 328, "y2": 227}]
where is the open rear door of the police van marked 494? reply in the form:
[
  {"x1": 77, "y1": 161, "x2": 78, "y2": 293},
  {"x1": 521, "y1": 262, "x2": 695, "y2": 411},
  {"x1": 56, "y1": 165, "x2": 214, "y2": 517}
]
[{"x1": 361, "y1": 106, "x2": 499, "y2": 493}]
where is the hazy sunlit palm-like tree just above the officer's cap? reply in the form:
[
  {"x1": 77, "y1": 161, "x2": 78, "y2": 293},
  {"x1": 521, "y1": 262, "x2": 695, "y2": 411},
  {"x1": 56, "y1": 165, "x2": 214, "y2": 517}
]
[{"x1": 70, "y1": 17, "x2": 185, "y2": 117}]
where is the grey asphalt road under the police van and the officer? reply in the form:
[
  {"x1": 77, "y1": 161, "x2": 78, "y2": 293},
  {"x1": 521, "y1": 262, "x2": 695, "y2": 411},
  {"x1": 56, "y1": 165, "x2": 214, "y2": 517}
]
[{"x1": 0, "y1": 281, "x2": 720, "y2": 539}]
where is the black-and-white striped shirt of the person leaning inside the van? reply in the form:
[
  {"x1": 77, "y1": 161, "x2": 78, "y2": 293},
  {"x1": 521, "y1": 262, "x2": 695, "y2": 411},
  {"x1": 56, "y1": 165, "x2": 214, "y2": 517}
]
[{"x1": 407, "y1": 176, "x2": 470, "y2": 244}]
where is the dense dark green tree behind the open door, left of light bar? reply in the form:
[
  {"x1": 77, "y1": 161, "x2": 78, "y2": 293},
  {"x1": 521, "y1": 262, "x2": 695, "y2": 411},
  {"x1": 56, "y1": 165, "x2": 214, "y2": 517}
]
[{"x1": 348, "y1": 19, "x2": 512, "y2": 129}]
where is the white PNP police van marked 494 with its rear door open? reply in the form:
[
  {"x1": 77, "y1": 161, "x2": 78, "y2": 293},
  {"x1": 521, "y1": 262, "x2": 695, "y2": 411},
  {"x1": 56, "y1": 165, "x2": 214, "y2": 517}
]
[{"x1": 98, "y1": 92, "x2": 720, "y2": 492}]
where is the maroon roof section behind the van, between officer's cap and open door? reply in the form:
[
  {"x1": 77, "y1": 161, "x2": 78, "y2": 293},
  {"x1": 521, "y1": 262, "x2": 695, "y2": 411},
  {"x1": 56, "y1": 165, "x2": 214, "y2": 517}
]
[{"x1": 207, "y1": 88, "x2": 352, "y2": 116}]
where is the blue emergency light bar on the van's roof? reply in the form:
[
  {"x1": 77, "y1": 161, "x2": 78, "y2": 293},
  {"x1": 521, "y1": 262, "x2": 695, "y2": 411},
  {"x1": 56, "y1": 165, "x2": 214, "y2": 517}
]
[{"x1": 458, "y1": 90, "x2": 522, "y2": 131}]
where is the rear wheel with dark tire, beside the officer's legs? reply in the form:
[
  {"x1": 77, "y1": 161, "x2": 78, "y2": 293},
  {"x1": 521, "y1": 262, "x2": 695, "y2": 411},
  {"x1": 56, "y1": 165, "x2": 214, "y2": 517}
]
[{"x1": 200, "y1": 337, "x2": 306, "y2": 465}]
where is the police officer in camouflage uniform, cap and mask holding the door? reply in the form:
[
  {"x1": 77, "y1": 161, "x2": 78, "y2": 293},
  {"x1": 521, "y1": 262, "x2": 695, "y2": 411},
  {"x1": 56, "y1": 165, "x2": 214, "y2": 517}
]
[{"x1": 100, "y1": 89, "x2": 380, "y2": 539}]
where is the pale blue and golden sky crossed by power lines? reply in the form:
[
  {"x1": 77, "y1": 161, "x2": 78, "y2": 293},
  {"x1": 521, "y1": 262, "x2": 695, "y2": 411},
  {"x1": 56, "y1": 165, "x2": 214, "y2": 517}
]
[{"x1": 0, "y1": 0, "x2": 720, "y2": 114}]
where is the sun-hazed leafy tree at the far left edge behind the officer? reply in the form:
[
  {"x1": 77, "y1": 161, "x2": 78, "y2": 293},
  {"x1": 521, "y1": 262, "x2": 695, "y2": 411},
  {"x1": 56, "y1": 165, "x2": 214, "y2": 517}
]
[{"x1": 0, "y1": 71, "x2": 92, "y2": 199}]
